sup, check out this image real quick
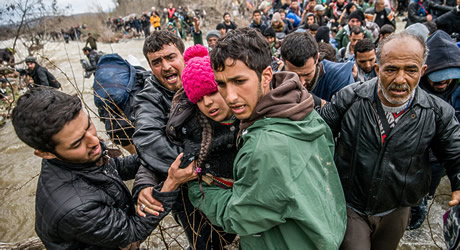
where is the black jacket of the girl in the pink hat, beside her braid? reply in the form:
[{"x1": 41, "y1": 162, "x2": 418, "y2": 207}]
[{"x1": 166, "y1": 89, "x2": 240, "y2": 179}]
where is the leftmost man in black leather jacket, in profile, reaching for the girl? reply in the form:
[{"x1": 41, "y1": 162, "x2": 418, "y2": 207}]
[{"x1": 13, "y1": 88, "x2": 192, "y2": 249}]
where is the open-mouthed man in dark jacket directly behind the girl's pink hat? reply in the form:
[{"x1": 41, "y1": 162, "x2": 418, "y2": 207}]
[{"x1": 133, "y1": 31, "x2": 229, "y2": 249}]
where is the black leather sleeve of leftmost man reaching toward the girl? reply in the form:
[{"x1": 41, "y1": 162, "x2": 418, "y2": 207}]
[{"x1": 58, "y1": 186, "x2": 179, "y2": 248}]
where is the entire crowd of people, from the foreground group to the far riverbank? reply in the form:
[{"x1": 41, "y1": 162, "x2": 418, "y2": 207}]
[{"x1": 5, "y1": 0, "x2": 460, "y2": 249}]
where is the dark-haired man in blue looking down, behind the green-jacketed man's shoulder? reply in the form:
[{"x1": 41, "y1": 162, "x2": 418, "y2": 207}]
[{"x1": 281, "y1": 32, "x2": 355, "y2": 101}]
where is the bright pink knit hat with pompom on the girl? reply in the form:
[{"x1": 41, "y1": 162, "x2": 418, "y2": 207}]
[{"x1": 182, "y1": 44, "x2": 217, "y2": 104}]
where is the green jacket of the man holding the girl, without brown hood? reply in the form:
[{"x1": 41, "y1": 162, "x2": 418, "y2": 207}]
[{"x1": 189, "y1": 111, "x2": 347, "y2": 250}]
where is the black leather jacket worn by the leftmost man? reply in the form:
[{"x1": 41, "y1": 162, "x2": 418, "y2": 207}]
[{"x1": 35, "y1": 146, "x2": 179, "y2": 249}]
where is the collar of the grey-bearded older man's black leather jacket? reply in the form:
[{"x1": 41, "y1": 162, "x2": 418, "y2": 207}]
[{"x1": 355, "y1": 77, "x2": 431, "y2": 108}]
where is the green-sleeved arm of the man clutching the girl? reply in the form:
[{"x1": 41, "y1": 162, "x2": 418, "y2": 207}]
[{"x1": 189, "y1": 135, "x2": 293, "y2": 236}]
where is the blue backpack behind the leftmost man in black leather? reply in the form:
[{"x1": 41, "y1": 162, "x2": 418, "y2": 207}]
[{"x1": 93, "y1": 54, "x2": 136, "y2": 112}]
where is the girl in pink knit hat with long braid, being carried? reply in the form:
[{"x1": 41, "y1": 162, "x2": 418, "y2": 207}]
[{"x1": 166, "y1": 45, "x2": 239, "y2": 248}]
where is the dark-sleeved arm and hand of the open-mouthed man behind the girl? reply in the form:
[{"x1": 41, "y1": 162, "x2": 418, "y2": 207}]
[{"x1": 133, "y1": 80, "x2": 182, "y2": 214}]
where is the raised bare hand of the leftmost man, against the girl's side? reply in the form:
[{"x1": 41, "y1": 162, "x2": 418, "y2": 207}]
[{"x1": 161, "y1": 153, "x2": 197, "y2": 192}]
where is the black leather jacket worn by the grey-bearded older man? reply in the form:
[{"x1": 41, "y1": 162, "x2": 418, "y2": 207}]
[{"x1": 321, "y1": 78, "x2": 460, "y2": 215}]
